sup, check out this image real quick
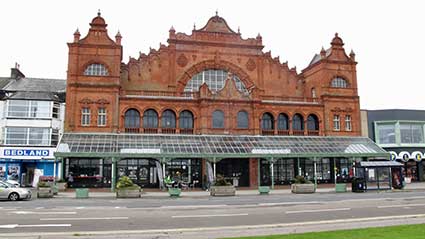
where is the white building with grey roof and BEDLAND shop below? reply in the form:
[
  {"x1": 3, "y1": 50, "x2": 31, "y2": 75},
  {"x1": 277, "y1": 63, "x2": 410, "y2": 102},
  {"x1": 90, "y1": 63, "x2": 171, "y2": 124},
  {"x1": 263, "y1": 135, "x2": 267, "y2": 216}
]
[{"x1": 0, "y1": 68, "x2": 66, "y2": 185}]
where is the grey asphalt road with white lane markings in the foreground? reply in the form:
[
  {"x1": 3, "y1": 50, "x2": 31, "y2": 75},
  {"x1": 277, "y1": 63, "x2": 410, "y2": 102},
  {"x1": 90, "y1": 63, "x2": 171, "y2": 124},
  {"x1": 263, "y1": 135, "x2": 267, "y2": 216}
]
[{"x1": 0, "y1": 191, "x2": 425, "y2": 239}]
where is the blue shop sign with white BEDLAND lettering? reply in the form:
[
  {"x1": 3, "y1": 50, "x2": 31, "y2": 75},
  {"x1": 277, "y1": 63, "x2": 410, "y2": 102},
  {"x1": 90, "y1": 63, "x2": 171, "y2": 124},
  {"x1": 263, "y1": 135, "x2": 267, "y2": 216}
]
[{"x1": 0, "y1": 147, "x2": 54, "y2": 159}]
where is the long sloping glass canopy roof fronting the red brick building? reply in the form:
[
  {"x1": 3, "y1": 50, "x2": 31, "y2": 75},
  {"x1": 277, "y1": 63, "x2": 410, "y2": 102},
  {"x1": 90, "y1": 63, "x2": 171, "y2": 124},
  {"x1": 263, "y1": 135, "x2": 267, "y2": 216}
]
[{"x1": 55, "y1": 133, "x2": 389, "y2": 158}]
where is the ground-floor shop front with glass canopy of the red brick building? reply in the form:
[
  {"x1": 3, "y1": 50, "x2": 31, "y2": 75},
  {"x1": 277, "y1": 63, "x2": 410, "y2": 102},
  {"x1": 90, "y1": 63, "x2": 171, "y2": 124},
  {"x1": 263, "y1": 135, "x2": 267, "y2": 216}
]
[{"x1": 55, "y1": 133, "x2": 389, "y2": 189}]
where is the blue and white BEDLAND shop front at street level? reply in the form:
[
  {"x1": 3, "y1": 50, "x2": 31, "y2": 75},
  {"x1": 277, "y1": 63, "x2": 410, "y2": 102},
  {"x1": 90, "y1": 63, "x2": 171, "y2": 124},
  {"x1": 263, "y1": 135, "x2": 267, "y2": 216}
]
[{"x1": 0, "y1": 147, "x2": 59, "y2": 186}]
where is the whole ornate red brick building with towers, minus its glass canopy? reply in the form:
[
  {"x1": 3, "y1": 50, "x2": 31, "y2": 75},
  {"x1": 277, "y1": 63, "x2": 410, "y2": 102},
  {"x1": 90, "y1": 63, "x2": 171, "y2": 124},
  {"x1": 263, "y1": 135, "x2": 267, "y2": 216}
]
[{"x1": 58, "y1": 13, "x2": 382, "y2": 190}]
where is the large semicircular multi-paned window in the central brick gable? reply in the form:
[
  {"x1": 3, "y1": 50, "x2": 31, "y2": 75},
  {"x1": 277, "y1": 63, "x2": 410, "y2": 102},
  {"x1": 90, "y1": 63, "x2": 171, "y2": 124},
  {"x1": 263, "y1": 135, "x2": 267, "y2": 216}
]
[{"x1": 184, "y1": 69, "x2": 248, "y2": 93}]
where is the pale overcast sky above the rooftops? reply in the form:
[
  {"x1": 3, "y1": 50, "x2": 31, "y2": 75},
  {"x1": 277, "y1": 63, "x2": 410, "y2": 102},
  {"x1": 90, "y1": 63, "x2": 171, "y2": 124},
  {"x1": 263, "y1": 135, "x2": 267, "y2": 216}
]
[{"x1": 0, "y1": 0, "x2": 425, "y2": 109}]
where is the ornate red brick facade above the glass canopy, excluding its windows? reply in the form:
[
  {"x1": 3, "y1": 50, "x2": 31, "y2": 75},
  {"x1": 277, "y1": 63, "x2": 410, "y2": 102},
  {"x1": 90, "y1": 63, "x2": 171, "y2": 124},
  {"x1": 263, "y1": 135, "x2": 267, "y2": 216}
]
[{"x1": 65, "y1": 14, "x2": 360, "y2": 136}]
